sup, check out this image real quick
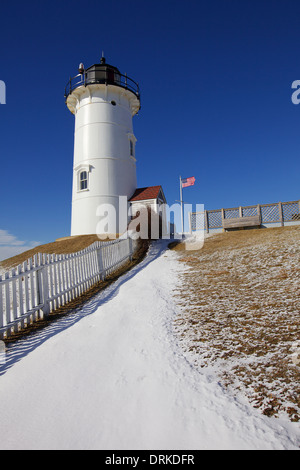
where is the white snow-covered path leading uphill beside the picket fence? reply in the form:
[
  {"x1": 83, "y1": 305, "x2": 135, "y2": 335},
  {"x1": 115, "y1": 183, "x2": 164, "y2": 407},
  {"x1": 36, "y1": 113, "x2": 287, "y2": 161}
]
[{"x1": 0, "y1": 242, "x2": 300, "y2": 450}]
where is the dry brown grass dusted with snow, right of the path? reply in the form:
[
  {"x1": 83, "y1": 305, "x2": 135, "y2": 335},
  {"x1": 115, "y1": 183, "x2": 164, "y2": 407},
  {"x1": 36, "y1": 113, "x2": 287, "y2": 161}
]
[{"x1": 172, "y1": 226, "x2": 300, "y2": 421}]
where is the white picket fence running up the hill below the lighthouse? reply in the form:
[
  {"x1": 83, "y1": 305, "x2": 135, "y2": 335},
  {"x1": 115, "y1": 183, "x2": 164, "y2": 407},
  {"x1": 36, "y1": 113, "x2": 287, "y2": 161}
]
[{"x1": 0, "y1": 238, "x2": 138, "y2": 338}]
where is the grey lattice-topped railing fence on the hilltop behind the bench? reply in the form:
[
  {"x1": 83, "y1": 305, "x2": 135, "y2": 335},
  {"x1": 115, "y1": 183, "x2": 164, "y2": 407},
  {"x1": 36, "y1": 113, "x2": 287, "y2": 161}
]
[{"x1": 189, "y1": 201, "x2": 300, "y2": 233}]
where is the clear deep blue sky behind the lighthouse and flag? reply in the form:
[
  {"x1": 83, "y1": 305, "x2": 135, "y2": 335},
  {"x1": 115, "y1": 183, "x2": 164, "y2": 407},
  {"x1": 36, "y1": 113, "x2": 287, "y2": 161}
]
[{"x1": 0, "y1": 0, "x2": 300, "y2": 259}]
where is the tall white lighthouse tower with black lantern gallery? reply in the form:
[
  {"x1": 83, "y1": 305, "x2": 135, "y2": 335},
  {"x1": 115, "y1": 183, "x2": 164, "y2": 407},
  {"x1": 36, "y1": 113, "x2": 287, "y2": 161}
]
[{"x1": 65, "y1": 57, "x2": 140, "y2": 235}]
